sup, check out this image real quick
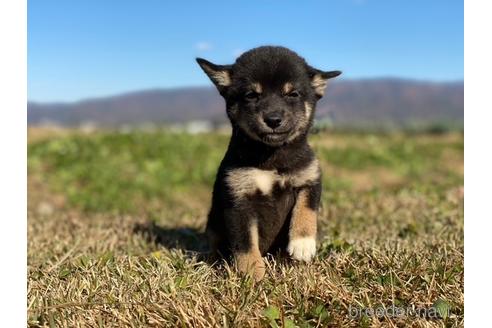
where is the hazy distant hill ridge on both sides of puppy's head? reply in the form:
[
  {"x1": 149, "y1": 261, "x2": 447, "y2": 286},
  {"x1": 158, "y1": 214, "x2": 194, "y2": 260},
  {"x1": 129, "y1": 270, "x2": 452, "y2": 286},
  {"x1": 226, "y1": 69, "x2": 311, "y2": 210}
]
[{"x1": 27, "y1": 79, "x2": 464, "y2": 127}]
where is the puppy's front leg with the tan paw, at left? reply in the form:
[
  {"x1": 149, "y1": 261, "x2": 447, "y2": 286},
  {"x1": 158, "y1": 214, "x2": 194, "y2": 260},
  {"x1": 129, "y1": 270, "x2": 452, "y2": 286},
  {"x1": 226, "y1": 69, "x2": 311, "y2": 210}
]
[{"x1": 226, "y1": 210, "x2": 265, "y2": 281}]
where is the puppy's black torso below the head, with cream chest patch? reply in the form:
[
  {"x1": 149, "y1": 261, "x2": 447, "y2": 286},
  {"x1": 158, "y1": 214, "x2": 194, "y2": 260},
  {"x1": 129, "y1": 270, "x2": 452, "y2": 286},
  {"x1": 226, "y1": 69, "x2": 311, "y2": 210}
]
[{"x1": 207, "y1": 131, "x2": 321, "y2": 255}]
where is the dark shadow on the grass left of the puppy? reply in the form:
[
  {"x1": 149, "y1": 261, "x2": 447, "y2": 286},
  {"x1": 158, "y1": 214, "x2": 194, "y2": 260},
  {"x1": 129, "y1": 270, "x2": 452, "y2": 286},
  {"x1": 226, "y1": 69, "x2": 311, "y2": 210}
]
[{"x1": 133, "y1": 222, "x2": 208, "y2": 258}]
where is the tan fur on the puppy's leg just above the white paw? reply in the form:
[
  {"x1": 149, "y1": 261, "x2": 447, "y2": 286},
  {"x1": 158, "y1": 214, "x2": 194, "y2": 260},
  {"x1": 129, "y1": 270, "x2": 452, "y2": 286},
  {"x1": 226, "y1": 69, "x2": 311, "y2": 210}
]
[{"x1": 289, "y1": 189, "x2": 317, "y2": 240}]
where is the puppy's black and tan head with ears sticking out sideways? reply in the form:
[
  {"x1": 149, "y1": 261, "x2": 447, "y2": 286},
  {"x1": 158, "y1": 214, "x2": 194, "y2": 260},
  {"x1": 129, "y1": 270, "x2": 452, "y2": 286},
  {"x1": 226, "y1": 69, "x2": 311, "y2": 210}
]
[{"x1": 197, "y1": 47, "x2": 341, "y2": 147}]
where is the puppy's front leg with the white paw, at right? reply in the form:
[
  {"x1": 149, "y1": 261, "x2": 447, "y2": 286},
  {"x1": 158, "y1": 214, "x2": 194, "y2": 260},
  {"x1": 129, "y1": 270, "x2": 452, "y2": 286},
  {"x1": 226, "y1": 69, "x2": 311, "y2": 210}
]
[{"x1": 287, "y1": 182, "x2": 321, "y2": 262}]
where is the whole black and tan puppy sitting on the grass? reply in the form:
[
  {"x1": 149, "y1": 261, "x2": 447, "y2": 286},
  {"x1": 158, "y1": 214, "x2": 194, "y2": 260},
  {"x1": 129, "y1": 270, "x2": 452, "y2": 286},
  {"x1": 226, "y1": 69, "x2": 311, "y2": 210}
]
[{"x1": 197, "y1": 47, "x2": 341, "y2": 280}]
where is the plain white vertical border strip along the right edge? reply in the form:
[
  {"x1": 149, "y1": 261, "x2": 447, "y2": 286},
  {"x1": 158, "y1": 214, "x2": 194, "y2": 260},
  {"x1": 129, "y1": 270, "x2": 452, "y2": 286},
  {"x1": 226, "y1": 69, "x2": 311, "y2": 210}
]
[{"x1": 465, "y1": 0, "x2": 492, "y2": 327}]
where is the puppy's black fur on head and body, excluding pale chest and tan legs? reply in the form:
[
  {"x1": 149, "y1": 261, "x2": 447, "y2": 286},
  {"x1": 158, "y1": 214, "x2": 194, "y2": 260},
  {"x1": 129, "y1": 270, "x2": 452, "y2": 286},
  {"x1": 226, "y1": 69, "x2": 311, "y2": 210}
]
[{"x1": 197, "y1": 47, "x2": 341, "y2": 262}]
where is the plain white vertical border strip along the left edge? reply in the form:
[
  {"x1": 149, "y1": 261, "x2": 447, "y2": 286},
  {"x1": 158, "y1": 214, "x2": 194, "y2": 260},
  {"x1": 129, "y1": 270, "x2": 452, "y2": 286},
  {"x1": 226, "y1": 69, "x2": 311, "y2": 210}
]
[{"x1": 0, "y1": 0, "x2": 27, "y2": 327}]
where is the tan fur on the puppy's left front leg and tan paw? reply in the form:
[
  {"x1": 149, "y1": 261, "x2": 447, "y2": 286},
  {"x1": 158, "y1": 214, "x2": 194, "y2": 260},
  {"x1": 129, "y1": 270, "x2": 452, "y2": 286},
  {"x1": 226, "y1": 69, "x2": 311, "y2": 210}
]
[{"x1": 234, "y1": 221, "x2": 265, "y2": 281}]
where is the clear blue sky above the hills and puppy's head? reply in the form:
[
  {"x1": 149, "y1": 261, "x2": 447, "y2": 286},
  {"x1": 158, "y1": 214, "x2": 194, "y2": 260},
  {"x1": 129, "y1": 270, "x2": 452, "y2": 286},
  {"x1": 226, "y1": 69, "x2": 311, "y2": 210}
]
[{"x1": 28, "y1": 0, "x2": 463, "y2": 101}]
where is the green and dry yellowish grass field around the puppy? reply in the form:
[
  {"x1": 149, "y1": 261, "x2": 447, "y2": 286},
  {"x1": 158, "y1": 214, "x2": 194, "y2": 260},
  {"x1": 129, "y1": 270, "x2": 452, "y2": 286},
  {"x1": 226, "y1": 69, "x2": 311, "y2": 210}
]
[{"x1": 27, "y1": 130, "x2": 464, "y2": 327}]
